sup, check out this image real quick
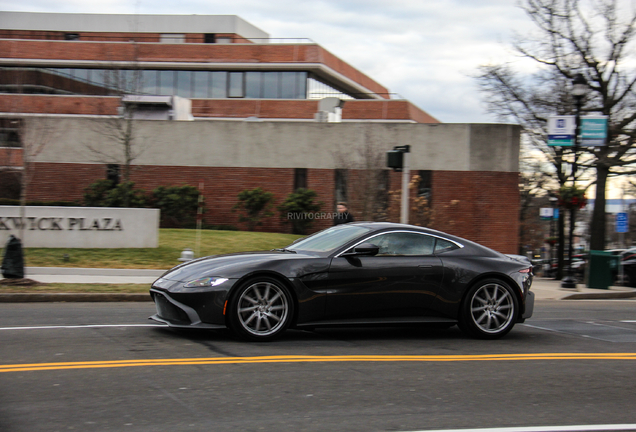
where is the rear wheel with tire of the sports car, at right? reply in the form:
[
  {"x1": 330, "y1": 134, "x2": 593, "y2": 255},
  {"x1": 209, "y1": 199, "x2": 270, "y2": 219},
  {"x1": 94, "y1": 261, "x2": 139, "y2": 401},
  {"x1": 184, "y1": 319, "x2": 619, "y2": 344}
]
[{"x1": 459, "y1": 279, "x2": 519, "y2": 339}]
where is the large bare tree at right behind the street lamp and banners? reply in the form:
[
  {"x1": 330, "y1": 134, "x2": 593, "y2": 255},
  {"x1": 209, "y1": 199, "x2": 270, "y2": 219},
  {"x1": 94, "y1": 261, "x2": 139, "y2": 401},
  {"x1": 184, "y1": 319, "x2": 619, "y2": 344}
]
[{"x1": 477, "y1": 0, "x2": 636, "y2": 250}]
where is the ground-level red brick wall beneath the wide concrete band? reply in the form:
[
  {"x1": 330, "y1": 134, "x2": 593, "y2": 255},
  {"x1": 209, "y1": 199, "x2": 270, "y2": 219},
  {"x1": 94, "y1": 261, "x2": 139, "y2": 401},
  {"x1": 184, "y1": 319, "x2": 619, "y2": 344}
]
[{"x1": 27, "y1": 163, "x2": 519, "y2": 253}]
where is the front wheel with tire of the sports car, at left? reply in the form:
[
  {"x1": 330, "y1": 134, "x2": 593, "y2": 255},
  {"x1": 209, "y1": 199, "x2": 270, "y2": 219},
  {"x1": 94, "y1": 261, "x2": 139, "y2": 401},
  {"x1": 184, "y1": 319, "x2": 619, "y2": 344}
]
[{"x1": 229, "y1": 277, "x2": 294, "y2": 341}]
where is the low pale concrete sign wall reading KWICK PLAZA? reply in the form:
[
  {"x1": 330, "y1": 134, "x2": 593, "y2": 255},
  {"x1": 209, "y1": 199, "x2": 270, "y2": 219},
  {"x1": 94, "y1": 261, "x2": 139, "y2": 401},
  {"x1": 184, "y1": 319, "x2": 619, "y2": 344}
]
[{"x1": 0, "y1": 206, "x2": 159, "y2": 248}]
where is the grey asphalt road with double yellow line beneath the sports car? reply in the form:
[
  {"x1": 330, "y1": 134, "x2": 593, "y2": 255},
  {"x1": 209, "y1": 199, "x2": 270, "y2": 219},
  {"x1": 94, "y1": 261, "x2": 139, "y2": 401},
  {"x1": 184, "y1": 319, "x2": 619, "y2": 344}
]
[{"x1": 0, "y1": 300, "x2": 636, "y2": 432}]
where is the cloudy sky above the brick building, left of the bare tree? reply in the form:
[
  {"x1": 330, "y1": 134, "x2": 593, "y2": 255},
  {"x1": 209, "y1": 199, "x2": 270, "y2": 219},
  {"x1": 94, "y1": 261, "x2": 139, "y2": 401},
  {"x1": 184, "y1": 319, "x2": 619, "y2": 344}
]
[{"x1": 0, "y1": 0, "x2": 533, "y2": 123}]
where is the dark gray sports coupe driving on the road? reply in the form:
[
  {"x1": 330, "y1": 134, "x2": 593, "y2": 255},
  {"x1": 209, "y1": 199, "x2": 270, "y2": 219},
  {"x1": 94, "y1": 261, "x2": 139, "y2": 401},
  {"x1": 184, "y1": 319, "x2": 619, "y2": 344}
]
[{"x1": 150, "y1": 222, "x2": 534, "y2": 340}]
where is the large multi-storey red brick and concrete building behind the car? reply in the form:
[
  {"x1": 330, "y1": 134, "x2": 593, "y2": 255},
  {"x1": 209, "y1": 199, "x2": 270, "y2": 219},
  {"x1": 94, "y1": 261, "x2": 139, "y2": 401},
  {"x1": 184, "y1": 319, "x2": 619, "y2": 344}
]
[{"x1": 0, "y1": 12, "x2": 519, "y2": 252}]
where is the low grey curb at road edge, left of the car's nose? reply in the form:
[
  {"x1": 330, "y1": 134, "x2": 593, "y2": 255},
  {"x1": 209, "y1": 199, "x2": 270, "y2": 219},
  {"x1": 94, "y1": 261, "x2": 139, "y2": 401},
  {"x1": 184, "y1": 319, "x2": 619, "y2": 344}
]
[{"x1": 0, "y1": 293, "x2": 152, "y2": 303}]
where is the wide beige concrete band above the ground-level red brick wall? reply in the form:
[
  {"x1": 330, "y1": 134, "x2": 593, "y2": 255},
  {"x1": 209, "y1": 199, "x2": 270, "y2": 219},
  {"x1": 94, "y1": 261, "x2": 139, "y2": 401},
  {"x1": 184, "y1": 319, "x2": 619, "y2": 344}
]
[{"x1": 29, "y1": 118, "x2": 520, "y2": 172}]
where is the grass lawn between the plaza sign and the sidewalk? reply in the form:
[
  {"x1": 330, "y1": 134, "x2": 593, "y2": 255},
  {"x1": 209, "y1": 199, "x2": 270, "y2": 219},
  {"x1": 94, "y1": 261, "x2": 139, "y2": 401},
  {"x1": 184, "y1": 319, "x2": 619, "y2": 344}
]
[{"x1": 19, "y1": 229, "x2": 300, "y2": 270}]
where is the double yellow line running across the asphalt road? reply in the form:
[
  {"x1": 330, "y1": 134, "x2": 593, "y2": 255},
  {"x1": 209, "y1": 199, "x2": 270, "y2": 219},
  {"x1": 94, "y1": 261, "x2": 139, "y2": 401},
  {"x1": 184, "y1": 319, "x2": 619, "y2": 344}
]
[{"x1": 0, "y1": 353, "x2": 636, "y2": 372}]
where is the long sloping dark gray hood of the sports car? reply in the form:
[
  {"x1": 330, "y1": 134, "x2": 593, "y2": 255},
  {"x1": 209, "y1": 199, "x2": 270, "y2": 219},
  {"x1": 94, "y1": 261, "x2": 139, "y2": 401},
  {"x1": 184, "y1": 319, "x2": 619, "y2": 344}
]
[{"x1": 161, "y1": 251, "x2": 315, "y2": 282}]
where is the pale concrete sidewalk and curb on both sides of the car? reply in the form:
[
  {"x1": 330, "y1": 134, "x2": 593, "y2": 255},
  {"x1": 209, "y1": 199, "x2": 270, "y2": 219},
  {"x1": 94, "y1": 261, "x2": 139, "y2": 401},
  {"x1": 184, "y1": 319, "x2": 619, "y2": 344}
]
[{"x1": 0, "y1": 267, "x2": 636, "y2": 302}]
